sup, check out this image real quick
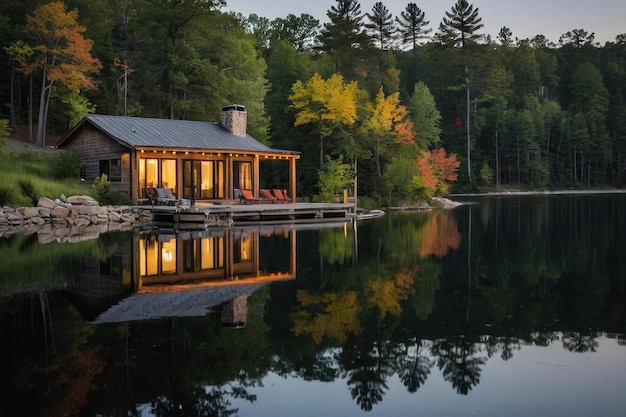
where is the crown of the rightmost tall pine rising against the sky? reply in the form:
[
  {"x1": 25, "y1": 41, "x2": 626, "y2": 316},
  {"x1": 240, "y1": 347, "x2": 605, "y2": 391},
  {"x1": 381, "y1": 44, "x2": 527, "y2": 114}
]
[{"x1": 439, "y1": 0, "x2": 484, "y2": 50}]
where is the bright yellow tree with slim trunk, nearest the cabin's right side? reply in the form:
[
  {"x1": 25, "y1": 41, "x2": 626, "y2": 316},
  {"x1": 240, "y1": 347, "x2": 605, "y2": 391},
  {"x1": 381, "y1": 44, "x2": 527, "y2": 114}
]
[{"x1": 289, "y1": 74, "x2": 358, "y2": 168}]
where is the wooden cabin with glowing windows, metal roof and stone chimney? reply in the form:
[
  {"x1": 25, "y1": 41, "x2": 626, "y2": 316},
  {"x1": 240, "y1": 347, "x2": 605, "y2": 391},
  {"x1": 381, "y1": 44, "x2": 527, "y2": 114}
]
[{"x1": 58, "y1": 104, "x2": 300, "y2": 201}]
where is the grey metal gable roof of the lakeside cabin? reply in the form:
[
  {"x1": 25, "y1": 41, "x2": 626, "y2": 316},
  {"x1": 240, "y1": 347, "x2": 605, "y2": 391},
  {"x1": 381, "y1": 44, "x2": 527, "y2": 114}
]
[{"x1": 62, "y1": 114, "x2": 300, "y2": 154}]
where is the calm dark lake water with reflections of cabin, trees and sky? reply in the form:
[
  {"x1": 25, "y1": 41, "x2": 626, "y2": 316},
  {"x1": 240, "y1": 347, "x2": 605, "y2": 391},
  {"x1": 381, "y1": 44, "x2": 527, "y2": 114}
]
[{"x1": 0, "y1": 194, "x2": 626, "y2": 417}]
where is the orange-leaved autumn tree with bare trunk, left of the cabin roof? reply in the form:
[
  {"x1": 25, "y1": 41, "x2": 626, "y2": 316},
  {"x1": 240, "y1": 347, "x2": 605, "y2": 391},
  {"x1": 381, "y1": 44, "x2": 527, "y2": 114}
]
[{"x1": 26, "y1": 1, "x2": 101, "y2": 146}]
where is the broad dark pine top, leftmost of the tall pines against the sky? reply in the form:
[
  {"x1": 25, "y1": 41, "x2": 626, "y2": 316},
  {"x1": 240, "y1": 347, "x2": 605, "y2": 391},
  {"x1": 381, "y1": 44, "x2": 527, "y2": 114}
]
[{"x1": 321, "y1": 0, "x2": 371, "y2": 78}]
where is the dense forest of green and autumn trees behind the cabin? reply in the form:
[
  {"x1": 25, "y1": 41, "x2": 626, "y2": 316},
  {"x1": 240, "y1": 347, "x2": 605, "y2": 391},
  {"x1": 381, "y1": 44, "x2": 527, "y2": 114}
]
[{"x1": 0, "y1": 0, "x2": 626, "y2": 204}]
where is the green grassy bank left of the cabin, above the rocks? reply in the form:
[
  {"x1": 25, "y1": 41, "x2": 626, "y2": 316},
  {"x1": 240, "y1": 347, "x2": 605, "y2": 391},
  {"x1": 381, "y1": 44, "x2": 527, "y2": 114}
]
[{"x1": 0, "y1": 149, "x2": 93, "y2": 207}]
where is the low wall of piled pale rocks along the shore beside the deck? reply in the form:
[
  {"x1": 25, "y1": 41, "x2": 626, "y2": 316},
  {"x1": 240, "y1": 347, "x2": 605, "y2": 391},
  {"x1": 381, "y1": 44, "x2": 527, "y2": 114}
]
[{"x1": 0, "y1": 195, "x2": 152, "y2": 243}]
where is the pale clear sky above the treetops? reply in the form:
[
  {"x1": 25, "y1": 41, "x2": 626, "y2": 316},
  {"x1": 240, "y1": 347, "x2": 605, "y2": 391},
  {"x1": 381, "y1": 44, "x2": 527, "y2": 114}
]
[{"x1": 223, "y1": 0, "x2": 626, "y2": 45}]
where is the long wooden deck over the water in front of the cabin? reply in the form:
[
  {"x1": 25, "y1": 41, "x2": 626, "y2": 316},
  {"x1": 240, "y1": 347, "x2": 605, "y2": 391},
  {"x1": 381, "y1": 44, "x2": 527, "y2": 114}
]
[{"x1": 145, "y1": 203, "x2": 354, "y2": 229}]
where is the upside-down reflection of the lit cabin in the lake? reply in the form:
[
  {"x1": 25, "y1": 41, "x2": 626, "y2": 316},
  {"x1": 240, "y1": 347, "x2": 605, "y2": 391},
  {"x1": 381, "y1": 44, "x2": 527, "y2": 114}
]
[{"x1": 94, "y1": 224, "x2": 296, "y2": 327}]
